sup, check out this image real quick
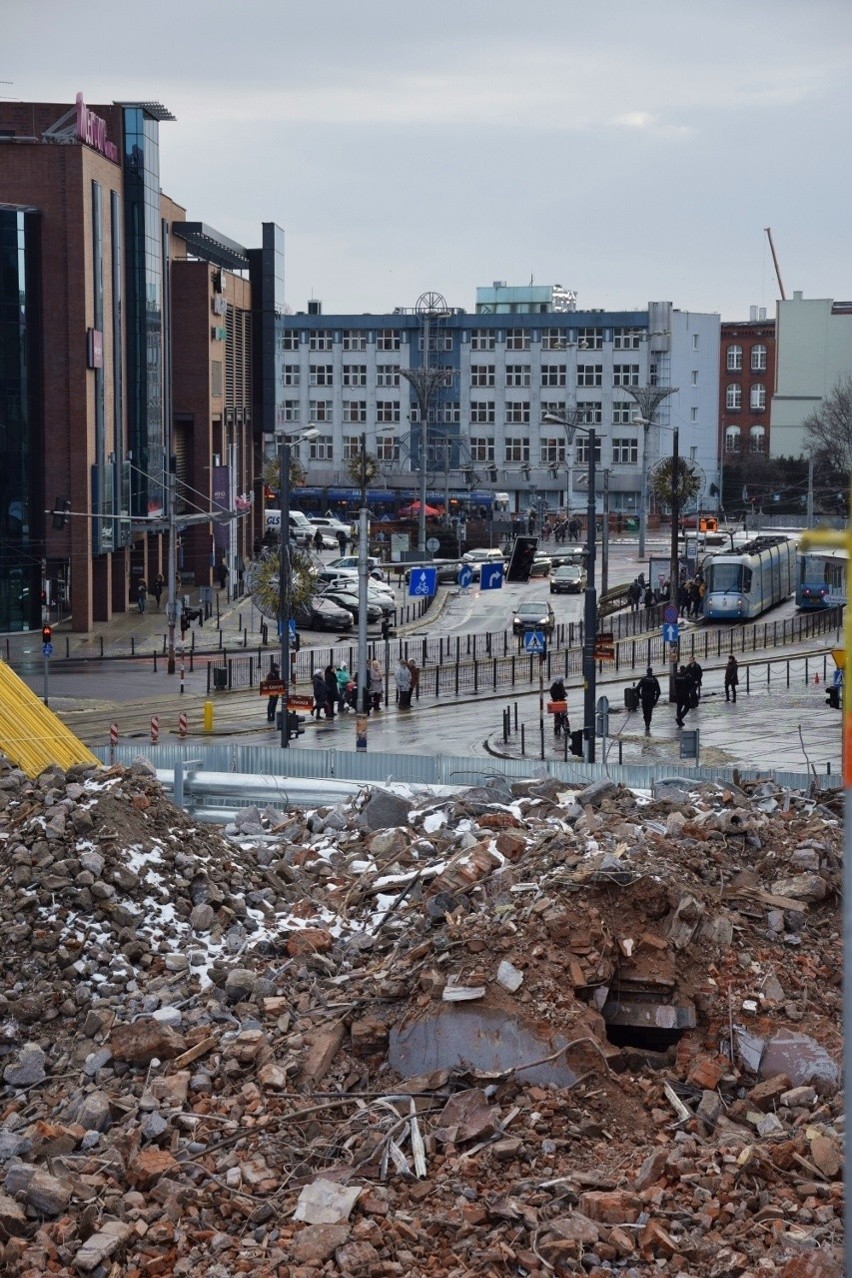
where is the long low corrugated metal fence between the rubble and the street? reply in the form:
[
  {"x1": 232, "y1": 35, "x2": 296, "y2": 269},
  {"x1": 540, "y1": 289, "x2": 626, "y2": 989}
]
[{"x1": 95, "y1": 744, "x2": 841, "y2": 790}]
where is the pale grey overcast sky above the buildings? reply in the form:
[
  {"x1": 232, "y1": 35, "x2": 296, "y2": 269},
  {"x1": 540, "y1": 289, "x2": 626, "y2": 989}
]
[{"x1": 6, "y1": 0, "x2": 852, "y2": 320}]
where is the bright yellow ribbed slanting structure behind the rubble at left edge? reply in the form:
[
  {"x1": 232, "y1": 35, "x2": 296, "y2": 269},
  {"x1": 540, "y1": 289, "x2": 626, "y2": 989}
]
[{"x1": 0, "y1": 662, "x2": 101, "y2": 777}]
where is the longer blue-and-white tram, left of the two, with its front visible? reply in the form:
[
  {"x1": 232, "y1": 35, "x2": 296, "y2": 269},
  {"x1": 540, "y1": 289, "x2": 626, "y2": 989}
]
[{"x1": 704, "y1": 537, "x2": 796, "y2": 621}]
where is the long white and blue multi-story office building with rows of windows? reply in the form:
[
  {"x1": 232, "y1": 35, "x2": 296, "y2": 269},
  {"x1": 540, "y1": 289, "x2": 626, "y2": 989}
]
[{"x1": 278, "y1": 284, "x2": 719, "y2": 514}]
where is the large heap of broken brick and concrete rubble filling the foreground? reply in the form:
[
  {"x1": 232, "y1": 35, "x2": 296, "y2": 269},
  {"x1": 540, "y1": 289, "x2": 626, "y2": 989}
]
[{"x1": 0, "y1": 762, "x2": 843, "y2": 1278}]
